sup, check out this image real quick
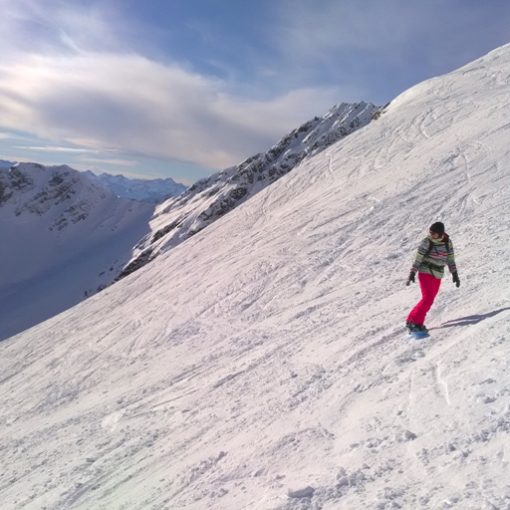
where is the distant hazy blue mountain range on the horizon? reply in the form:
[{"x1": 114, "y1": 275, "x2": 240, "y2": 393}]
[{"x1": 84, "y1": 170, "x2": 187, "y2": 204}]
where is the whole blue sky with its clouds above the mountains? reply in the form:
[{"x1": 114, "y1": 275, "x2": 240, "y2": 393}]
[{"x1": 0, "y1": 0, "x2": 510, "y2": 184}]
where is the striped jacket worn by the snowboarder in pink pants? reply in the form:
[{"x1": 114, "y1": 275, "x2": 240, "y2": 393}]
[{"x1": 411, "y1": 234, "x2": 457, "y2": 278}]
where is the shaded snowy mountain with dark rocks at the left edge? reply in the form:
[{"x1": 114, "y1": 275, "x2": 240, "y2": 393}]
[{"x1": 0, "y1": 163, "x2": 154, "y2": 339}]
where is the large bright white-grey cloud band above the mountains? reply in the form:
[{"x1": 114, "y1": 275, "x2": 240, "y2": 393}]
[{"x1": 0, "y1": 52, "x2": 338, "y2": 168}]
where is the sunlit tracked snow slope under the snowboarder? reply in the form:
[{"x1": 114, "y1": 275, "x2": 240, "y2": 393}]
[{"x1": 0, "y1": 46, "x2": 510, "y2": 510}]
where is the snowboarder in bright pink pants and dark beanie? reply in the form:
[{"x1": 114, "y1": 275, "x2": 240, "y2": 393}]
[{"x1": 406, "y1": 221, "x2": 460, "y2": 335}]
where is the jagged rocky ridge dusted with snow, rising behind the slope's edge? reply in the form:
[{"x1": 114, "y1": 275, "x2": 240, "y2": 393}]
[{"x1": 116, "y1": 103, "x2": 378, "y2": 278}]
